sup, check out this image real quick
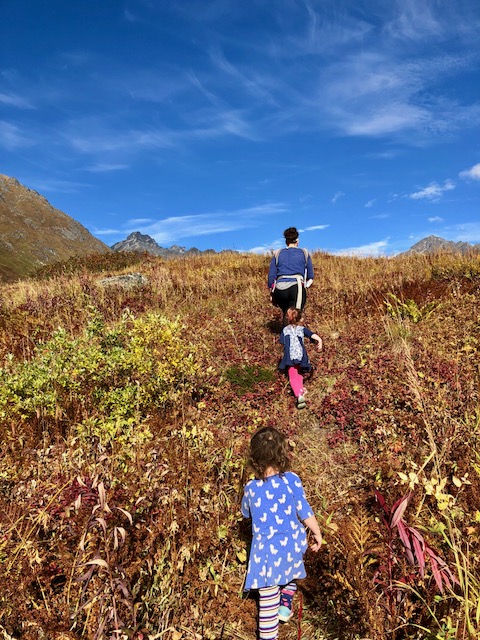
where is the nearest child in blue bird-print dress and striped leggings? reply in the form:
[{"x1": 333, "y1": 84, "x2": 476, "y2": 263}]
[{"x1": 241, "y1": 427, "x2": 322, "y2": 640}]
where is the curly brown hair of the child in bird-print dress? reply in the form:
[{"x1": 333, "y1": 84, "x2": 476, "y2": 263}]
[{"x1": 249, "y1": 427, "x2": 290, "y2": 478}]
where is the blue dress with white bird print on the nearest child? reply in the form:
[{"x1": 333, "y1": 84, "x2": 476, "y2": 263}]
[{"x1": 241, "y1": 471, "x2": 313, "y2": 591}]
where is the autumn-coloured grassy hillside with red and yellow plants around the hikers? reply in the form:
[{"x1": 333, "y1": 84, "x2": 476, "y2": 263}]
[{"x1": 0, "y1": 254, "x2": 480, "y2": 640}]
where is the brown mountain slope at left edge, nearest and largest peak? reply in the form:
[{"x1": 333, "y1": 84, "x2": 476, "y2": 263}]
[{"x1": 0, "y1": 174, "x2": 111, "y2": 282}]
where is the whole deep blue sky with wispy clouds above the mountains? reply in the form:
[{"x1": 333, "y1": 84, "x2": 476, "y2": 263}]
[{"x1": 0, "y1": 0, "x2": 480, "y2": 255}]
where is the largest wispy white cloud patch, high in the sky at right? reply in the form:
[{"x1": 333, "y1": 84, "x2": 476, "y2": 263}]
[{"x1": 320, "y1": 51, "x2": 479, "y2": 144}]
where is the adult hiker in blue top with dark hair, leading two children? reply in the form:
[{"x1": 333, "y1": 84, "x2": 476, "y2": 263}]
[{"x1": 268, "y1": 227, "x2": 314, "y2": 325}]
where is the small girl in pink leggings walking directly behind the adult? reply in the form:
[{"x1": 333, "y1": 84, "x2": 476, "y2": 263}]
[{"x1": 278, "y1": 307, "x2": 322, "y2": 409}]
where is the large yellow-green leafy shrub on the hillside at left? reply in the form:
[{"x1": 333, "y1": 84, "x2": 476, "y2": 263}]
[{"x1": 0, "y1": 312, "x2": 198, "y2": 440}]
